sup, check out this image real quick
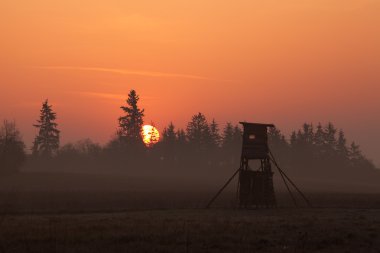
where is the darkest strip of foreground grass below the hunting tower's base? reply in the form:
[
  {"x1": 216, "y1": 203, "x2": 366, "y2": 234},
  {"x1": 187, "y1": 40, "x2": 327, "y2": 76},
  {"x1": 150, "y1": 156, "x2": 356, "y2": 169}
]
[{"x1": 0, "y1": 209, "x2": 380, "y2": 253}]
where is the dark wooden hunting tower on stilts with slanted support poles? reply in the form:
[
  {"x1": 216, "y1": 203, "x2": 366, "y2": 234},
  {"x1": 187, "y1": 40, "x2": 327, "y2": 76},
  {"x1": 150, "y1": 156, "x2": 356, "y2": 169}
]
[{"x1": 207, "y1": 122, "x2": 311, "y2": 208}]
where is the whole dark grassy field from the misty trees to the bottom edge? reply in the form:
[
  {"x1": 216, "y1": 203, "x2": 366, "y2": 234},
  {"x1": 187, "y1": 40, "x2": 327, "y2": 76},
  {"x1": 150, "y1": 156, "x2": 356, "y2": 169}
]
[{"x1": 0, "y1": 173, "x2": 380, "y2": 252}]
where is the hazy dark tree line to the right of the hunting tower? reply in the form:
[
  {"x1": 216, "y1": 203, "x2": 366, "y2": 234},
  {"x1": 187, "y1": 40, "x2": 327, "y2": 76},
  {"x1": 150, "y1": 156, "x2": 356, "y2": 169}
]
[{"x1": 269, "y1": 122, "x2": 376, "y2": 178}]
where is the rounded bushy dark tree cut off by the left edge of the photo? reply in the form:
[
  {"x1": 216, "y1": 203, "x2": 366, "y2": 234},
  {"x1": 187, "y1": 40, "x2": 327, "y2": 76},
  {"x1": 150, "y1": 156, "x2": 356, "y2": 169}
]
[{"x1": 0, "y1": 120, "x2": 26, "y2": 174}]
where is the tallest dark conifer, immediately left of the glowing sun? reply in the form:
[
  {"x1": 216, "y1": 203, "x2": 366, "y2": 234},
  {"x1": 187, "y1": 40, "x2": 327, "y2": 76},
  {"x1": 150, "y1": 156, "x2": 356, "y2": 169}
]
[{"x1": 117, "y1": 90, "x2": 144, "y2": 143}]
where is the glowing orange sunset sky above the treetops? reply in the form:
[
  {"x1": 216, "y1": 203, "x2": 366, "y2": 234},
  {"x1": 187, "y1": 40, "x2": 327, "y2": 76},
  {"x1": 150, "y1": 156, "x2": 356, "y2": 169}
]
[{"x1": 0, "y1": 0, "x2": 380, "y2": 164}]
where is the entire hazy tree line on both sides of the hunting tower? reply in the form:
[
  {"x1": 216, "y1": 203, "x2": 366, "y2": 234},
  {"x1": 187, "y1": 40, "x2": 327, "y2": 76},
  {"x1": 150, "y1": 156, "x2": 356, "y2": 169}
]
[{"x1": 0, "y1": 90, "x2": 375, "y2": 179}]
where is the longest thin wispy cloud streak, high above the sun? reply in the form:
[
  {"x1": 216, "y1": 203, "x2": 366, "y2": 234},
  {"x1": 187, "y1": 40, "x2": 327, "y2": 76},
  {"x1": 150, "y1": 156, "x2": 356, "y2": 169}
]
[{"x1": 33, "y1": 66, "x2": 233, "y2": 82}]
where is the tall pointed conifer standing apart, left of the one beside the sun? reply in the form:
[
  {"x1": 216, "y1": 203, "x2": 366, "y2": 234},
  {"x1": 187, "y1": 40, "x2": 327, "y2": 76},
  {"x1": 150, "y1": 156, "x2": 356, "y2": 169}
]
[{"x1": 32, "y1": 100, "x2": 60, "y2": 157}]
